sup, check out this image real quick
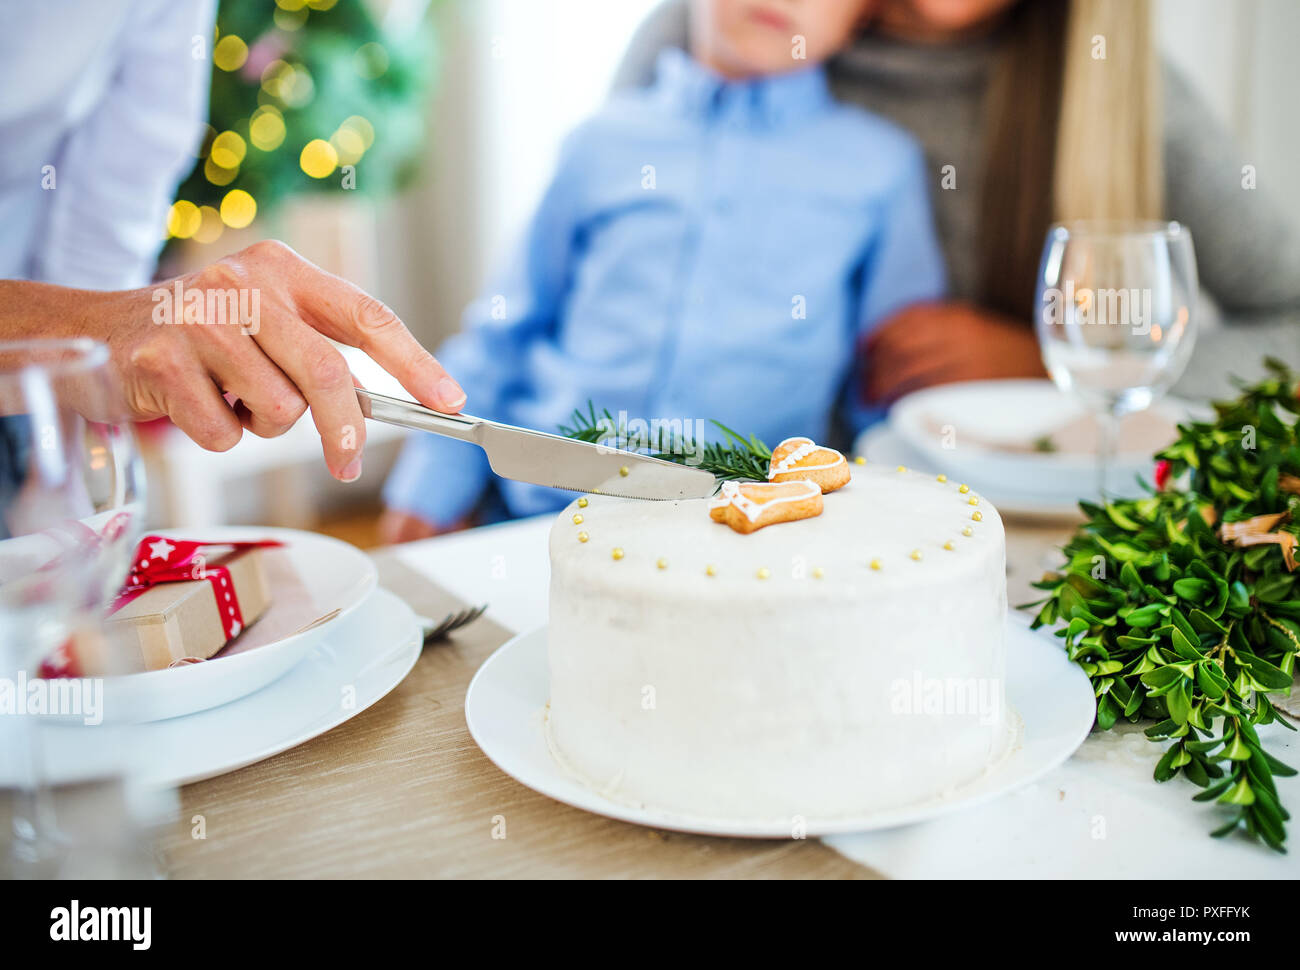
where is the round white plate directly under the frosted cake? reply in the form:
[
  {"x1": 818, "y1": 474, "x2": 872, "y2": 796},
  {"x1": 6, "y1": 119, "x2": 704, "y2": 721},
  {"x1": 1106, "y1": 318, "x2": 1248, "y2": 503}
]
[{"x1": 465, "y1": 618, "x2": 1096, "y2": 839}]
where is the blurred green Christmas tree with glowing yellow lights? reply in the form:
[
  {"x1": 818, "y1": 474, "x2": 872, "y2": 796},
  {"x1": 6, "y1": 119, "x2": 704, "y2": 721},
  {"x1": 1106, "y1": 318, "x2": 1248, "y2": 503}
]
[{"x1": 168, "y1": 0, "x2": 433, "y2": 242}]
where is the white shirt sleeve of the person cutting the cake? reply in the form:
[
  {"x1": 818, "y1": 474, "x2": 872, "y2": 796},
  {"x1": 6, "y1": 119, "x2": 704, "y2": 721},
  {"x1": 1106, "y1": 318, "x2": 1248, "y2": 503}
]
[{"x1": 33, "y1": 0, "x2": 216, "y2": 290}]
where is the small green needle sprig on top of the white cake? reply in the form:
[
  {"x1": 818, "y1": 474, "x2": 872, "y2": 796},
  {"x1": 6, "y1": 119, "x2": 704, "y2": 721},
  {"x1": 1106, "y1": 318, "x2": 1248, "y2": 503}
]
[{"x1": 559, "y1": 402, "x2": 772, "y2": 481}]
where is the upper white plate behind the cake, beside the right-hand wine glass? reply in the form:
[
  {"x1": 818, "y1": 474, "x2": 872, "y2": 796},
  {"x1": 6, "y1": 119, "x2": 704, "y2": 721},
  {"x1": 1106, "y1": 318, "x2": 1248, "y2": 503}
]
[{"x1": 889, "y1": 380, "x2": 1188, "y2": 502}]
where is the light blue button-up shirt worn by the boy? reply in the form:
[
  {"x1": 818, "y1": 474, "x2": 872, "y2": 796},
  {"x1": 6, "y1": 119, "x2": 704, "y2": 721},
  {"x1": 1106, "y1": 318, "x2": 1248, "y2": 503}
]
[{"x1": 385, "y1": 49, "x2": 944, "y2": 525}]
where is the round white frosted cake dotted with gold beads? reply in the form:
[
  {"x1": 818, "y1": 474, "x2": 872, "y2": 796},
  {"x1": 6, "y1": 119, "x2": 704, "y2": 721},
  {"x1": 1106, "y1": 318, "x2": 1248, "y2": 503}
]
[{"x1": 547, "y1": 465, "x2": 1013, "y2": 822}]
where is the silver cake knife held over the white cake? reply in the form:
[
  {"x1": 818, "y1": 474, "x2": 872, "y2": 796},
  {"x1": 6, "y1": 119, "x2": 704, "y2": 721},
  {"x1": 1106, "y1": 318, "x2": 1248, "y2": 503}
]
[{"x1": 356, "y1": 387, "x2": 716, "y2": 499}]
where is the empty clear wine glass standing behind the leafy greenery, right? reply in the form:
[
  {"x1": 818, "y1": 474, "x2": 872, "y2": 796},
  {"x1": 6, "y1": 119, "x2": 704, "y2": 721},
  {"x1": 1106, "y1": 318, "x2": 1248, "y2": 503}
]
[{"x1": 1035, "y1": 221, "x2": 1197, "y2": 501}]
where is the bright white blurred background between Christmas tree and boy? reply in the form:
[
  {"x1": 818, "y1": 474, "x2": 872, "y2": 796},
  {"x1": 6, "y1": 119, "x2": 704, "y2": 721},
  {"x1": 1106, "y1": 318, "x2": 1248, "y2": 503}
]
[{"x1": 381, "y1": 0, "x2": 657, "y2": 346}]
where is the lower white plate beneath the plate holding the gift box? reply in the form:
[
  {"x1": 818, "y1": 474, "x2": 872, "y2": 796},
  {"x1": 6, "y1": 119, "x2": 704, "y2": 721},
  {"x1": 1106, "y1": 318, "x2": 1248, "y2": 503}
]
[{"x1": 8, "y1": 589, "x2": 423, "y2": 788}]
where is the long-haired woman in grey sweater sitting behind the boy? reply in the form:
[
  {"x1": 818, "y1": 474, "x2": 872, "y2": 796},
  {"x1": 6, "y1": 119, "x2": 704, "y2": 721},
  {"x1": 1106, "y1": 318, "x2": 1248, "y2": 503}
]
[{"x1": 615, "y1": 0, "x2": 1300, "y2": 403}]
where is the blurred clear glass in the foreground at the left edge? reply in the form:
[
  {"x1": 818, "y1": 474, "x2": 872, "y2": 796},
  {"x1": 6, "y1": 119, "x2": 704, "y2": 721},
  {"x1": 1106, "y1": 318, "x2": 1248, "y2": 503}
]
[{"x1": 0, "y1": 339, "x2": 144, "y2": 875}]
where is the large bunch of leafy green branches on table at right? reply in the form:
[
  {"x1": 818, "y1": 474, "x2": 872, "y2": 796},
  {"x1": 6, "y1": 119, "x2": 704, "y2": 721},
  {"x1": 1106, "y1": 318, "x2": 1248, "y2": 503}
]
[{"x1": 1027, "y1": 359, "x2": 1300, "y2": 852}]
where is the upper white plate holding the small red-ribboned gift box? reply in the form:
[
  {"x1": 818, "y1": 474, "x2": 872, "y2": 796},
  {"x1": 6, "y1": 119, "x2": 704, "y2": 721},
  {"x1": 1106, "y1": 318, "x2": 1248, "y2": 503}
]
[{"x1": 104, "y1": 525, "x2": 376, "y2": 722}]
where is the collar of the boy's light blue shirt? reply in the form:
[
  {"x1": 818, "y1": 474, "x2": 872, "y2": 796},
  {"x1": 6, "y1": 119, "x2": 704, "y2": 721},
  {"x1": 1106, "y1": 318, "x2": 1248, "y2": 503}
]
[{"x1": 655, "y1": 47, "x2": 832, "y2": 125}]
